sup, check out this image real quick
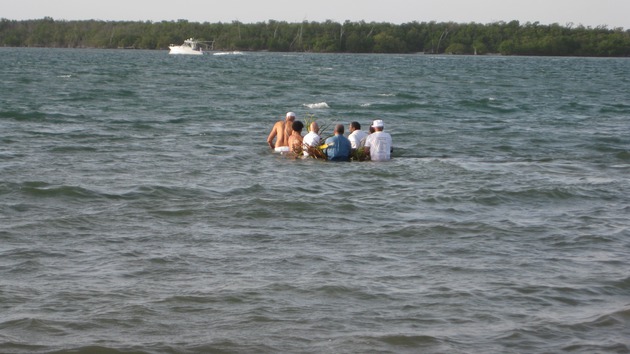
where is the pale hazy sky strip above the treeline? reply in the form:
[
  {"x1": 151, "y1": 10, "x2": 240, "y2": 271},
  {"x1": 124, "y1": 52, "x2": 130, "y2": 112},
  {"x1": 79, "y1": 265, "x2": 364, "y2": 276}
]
[{"x1": 0, "y1": 0, "x2": 630, "y2": 29}]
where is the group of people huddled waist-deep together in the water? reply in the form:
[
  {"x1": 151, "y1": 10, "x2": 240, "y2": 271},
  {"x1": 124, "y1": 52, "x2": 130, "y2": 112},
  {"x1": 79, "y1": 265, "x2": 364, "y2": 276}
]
[{"x1": 267, "y1": 112, "x2": 393, "y2": 161}]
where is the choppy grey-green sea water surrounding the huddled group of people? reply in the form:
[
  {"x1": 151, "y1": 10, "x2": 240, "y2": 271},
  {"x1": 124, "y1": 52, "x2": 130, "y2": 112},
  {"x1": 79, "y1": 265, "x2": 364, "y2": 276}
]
[{"x1": 0, "y1": 48, "x2": 630, "y2": 353}]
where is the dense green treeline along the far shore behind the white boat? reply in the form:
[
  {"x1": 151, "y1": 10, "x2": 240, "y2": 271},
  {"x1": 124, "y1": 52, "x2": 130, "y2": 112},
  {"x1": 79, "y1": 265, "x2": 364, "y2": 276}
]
[{"x1": 0, "y1": 17, "x2": 630, "y2": 57}]
